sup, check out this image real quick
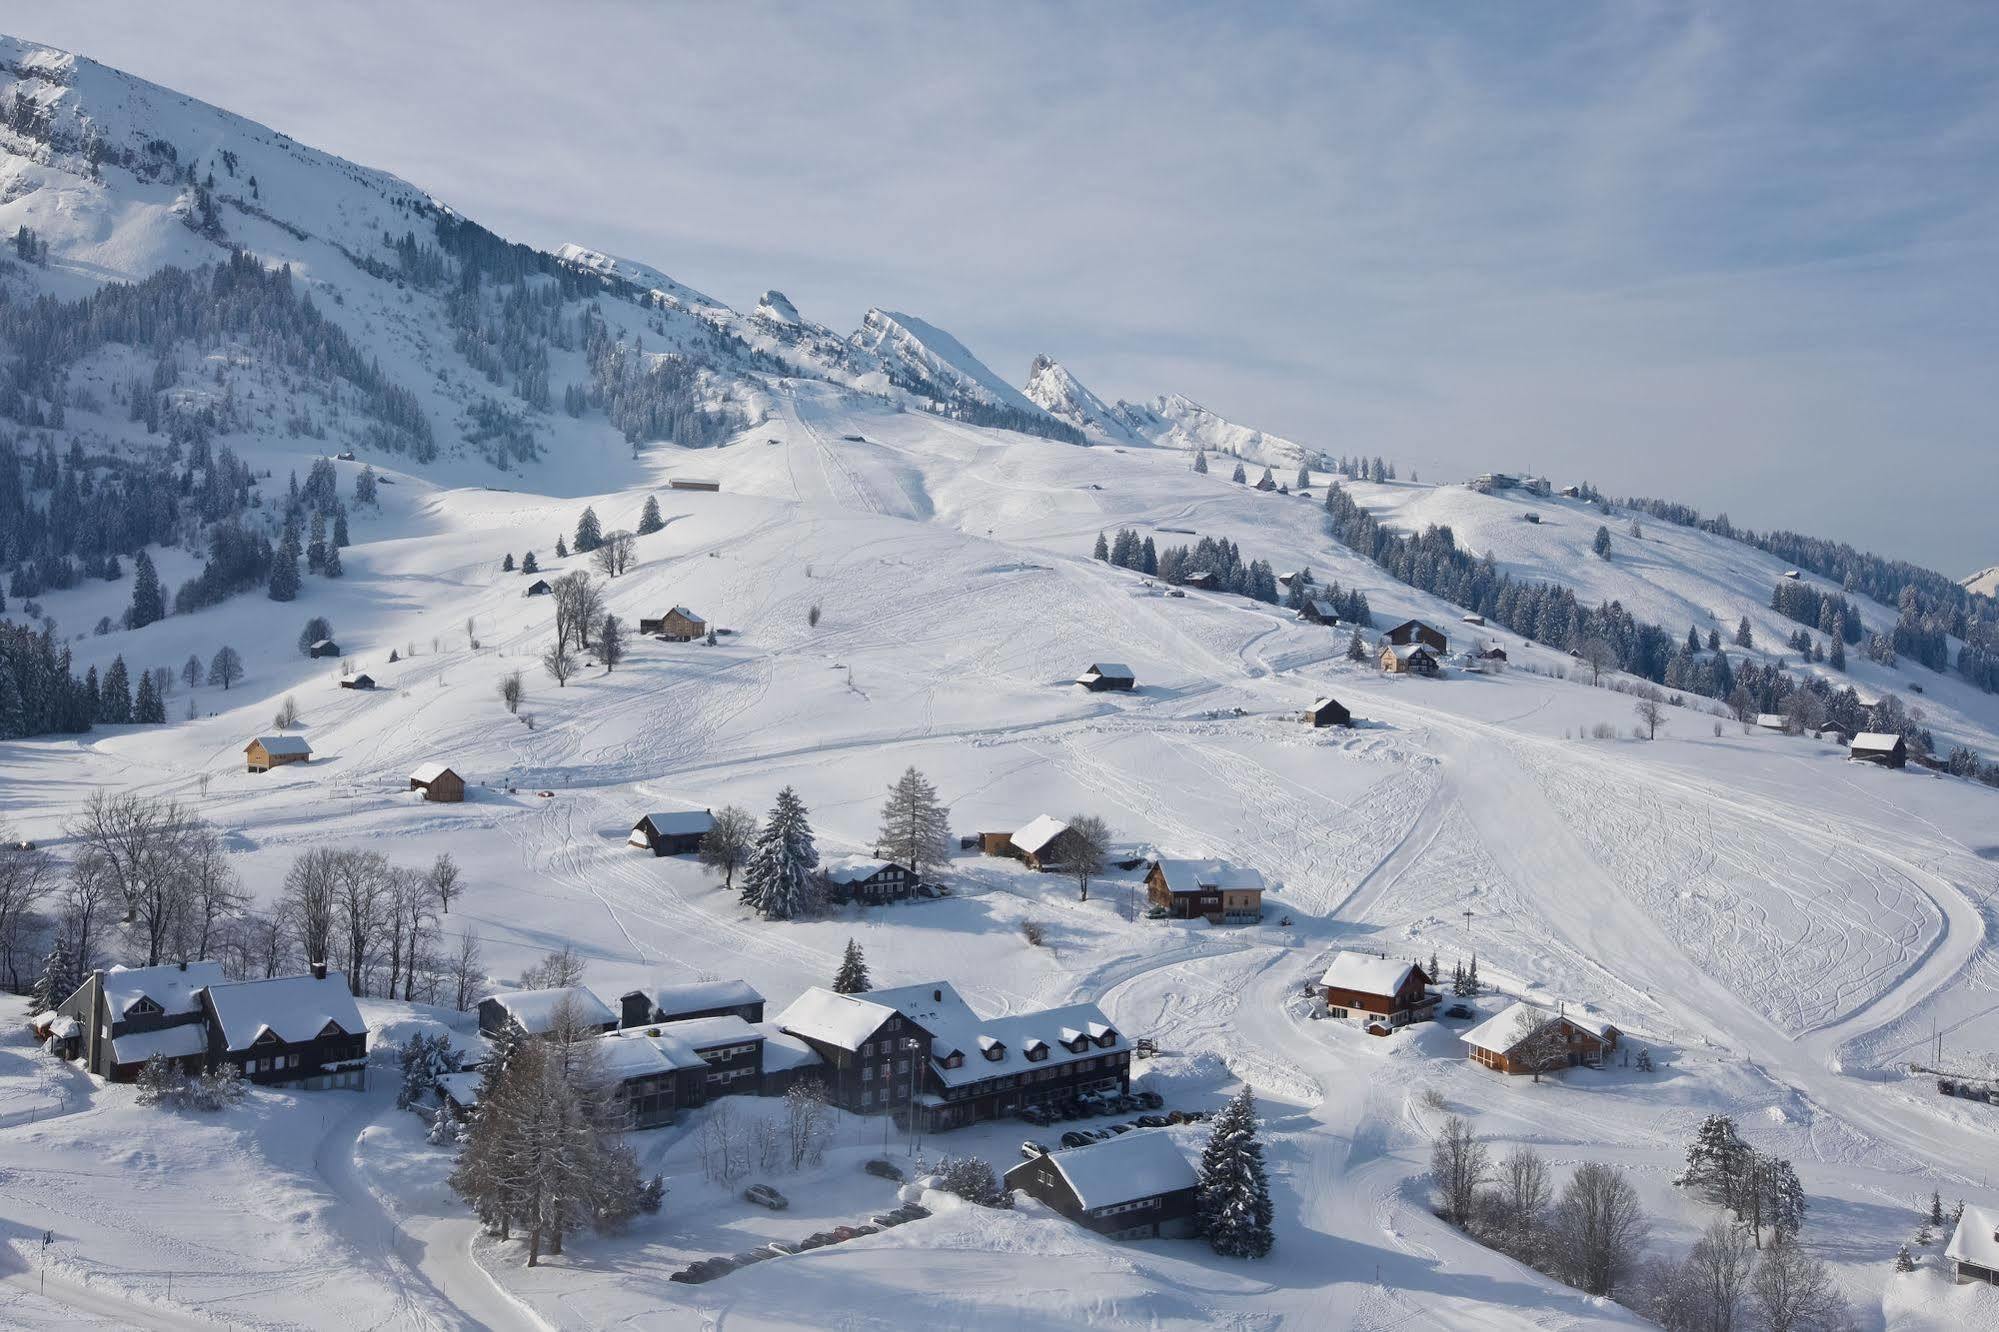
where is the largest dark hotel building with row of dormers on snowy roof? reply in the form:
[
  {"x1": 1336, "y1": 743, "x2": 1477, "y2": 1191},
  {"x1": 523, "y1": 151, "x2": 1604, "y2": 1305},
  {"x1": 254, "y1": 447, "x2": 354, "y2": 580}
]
[{"x1": 778, "y1": 980, "x2": 1131, "y2": 1132}]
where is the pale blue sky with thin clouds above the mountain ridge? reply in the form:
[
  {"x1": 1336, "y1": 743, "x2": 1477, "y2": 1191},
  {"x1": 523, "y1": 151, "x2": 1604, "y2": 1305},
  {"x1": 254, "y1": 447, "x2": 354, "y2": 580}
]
[{"x1": 15, "y1": 0, "x2": 1999, "y2": 574}]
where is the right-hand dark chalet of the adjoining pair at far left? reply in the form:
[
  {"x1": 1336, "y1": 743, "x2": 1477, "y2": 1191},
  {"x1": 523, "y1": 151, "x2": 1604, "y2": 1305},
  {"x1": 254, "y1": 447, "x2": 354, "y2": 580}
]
[{"x1": 202, "y1": 962, "x2": 368, "y2": 1090}]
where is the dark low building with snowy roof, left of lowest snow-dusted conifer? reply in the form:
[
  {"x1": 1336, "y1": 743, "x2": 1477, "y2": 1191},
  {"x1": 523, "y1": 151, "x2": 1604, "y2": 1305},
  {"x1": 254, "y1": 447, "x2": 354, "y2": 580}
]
[{"x1": 1005, "y1": 1128, "x2": 1199, "y2": 1240}]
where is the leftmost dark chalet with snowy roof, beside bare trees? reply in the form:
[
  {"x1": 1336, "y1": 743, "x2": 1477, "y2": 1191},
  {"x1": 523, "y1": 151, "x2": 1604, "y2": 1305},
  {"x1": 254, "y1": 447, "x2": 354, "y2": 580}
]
[{"x1": 46, "y1": 962, "x2": 222, "y2": 1082}]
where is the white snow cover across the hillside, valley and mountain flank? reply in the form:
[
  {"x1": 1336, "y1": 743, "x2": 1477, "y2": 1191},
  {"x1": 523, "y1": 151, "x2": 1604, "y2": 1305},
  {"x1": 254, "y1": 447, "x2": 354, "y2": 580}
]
[{"x1": 0, "y1": 28, "x2": 1999, "y2": 1330}]
